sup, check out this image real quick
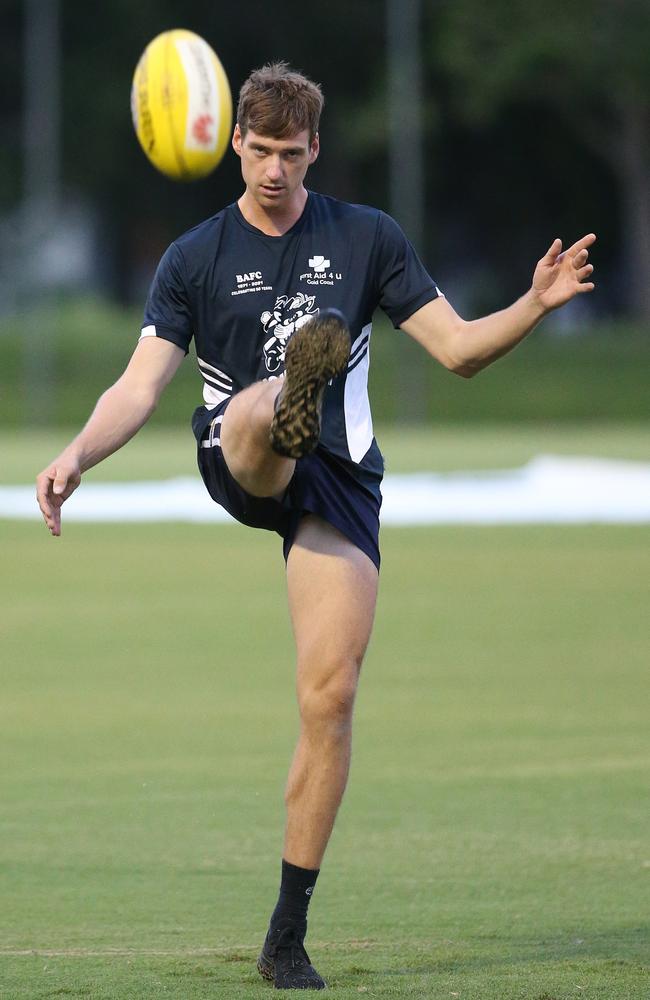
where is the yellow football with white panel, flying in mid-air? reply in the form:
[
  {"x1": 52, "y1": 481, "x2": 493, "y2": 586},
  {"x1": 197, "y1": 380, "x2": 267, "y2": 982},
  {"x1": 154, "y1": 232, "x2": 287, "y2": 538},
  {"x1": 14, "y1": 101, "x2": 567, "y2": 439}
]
[{"x1": 131, "y1": 28, "x2": 232, "y2": 181}]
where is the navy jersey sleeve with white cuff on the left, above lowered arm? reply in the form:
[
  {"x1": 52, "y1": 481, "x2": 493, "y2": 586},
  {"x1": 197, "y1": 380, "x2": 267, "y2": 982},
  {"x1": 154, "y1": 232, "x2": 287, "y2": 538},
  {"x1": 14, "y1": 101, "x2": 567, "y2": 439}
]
[{"x1": 140, "y1": 243, "x2": 193, "y2": 354}]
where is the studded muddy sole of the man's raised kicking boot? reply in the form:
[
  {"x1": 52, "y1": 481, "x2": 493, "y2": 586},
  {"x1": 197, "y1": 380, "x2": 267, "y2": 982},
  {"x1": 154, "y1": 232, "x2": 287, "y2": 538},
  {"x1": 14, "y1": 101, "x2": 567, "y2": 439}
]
[{"x1": 269, "y1": 309, "x2": 350, "y2": 458}]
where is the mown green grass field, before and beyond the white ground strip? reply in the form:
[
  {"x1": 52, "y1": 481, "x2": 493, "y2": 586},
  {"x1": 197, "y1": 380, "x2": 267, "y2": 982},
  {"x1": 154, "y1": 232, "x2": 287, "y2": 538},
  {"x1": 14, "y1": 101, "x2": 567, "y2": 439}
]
[{"x1": 0, "y1": 427, "x2": 650, "y2": 1000}]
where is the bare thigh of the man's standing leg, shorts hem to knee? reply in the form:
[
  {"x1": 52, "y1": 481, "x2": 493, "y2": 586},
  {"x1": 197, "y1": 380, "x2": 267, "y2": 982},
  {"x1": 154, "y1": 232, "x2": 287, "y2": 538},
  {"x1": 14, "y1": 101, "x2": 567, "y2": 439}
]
[{"x1": 287, "y1": 515, "x2": 379, "y2": 689}]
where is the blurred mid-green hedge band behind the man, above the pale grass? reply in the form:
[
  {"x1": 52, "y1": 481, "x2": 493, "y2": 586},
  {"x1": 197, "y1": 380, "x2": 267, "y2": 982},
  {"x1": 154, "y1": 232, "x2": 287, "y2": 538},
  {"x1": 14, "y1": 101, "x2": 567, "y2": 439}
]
[{"x1": 0, "y1": 300, "x2": 650, "y2": 427}]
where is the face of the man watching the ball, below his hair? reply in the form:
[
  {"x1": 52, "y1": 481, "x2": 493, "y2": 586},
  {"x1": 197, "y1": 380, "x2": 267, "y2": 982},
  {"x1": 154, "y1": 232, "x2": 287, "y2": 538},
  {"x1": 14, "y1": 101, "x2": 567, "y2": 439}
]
[{"x1": 232, "y1": 125, "x2": 319, "y2": 209}]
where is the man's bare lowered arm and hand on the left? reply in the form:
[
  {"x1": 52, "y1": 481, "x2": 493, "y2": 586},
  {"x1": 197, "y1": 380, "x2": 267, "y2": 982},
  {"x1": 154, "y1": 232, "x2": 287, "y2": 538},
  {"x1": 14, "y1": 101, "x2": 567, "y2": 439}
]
[{"x1": 36, "y1": 337, "x2": 185, "y2": 535}]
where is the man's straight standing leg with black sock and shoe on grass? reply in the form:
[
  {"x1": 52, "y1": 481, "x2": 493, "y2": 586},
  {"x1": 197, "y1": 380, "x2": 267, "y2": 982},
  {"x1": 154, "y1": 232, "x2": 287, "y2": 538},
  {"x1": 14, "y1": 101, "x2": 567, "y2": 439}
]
[{"x1": 259, "y1": 515, "x2": 378, "y2": 989}]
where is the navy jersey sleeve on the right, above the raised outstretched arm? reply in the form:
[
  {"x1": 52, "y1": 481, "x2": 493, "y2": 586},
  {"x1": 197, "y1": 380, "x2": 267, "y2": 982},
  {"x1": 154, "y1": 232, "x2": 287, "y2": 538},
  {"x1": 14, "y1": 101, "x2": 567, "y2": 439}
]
[{"x1": 376, "y1": 212, "x2": 442, "y2": 329}]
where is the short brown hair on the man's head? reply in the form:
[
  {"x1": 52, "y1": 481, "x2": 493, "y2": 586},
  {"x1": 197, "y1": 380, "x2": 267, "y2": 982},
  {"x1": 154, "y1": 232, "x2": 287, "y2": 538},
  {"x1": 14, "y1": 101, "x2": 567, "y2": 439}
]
[{"x1": 237, "y1": 62, "x2": 325, "y2": 142}]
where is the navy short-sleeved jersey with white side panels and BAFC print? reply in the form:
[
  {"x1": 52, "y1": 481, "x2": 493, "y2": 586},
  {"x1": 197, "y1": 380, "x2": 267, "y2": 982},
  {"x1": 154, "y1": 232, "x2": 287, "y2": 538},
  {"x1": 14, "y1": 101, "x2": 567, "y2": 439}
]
[{"x1": 142, "y1": 192, "x2": 440, "y2": 492}]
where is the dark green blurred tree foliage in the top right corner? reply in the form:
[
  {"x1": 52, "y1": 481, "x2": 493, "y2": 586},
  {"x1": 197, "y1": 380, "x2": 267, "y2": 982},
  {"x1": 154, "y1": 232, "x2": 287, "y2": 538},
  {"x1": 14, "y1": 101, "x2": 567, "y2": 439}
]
[{"x1": 431, "y1": 0, "x2": 650, "y2": 321}]
